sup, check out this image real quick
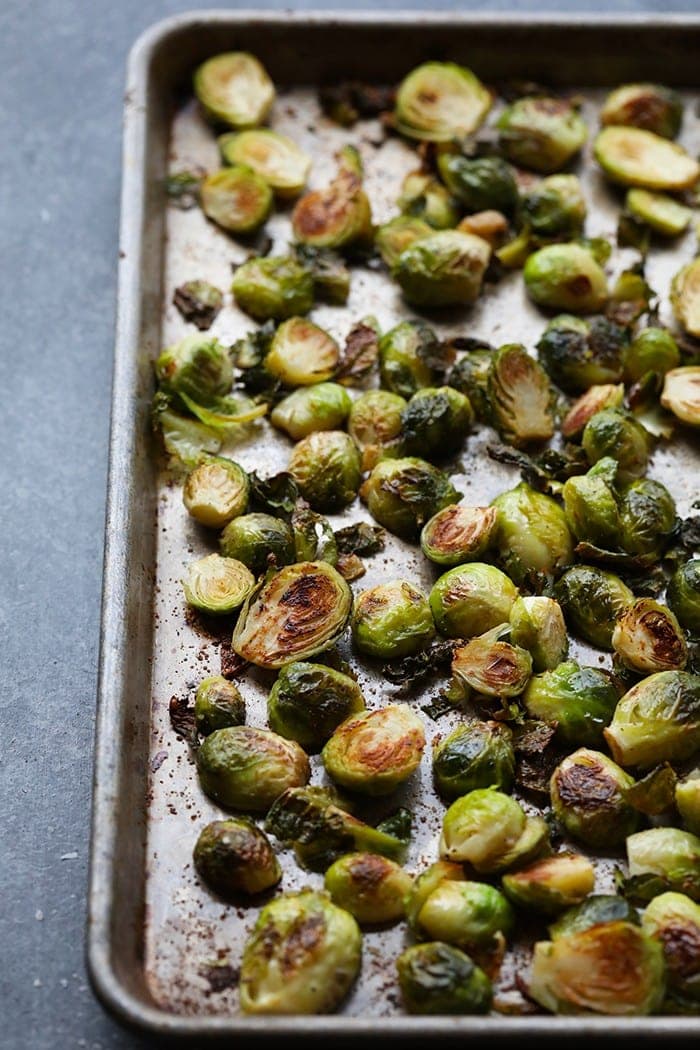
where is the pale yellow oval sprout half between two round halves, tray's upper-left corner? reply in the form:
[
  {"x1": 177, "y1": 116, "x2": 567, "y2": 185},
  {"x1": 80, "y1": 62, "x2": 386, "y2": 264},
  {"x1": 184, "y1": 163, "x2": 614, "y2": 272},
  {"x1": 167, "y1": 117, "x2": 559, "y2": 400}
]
[{"x1": 217, "y1": 128, "x2": 311, "y2": 197}]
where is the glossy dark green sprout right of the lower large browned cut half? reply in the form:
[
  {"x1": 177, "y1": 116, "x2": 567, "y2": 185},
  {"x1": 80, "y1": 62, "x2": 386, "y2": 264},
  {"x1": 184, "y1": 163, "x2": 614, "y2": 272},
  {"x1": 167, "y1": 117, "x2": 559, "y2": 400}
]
[{"x1": 432, "y1": 721, "x2": 515, "y2": 799}]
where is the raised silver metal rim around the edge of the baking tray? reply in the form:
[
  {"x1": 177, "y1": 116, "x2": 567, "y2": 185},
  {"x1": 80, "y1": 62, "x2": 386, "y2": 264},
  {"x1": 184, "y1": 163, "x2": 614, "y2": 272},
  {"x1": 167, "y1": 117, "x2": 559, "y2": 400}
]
[{"x1": 86, "y1": 9, "x2": 700, "y2": 1040}]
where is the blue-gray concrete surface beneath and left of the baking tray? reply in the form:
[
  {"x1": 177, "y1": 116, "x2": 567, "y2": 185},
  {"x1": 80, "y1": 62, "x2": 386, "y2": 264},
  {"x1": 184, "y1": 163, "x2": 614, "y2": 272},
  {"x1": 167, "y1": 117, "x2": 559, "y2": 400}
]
[{"x1": 0, "y1": 0, "x2": 698, "y2": 1050}]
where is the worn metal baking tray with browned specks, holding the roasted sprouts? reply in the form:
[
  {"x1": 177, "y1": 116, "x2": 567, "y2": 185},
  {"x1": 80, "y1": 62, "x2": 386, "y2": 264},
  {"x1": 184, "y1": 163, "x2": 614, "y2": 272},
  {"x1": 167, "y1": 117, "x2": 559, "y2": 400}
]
[{"x1": 88, "y1": 12, "x2": 700, "y2": 1038}]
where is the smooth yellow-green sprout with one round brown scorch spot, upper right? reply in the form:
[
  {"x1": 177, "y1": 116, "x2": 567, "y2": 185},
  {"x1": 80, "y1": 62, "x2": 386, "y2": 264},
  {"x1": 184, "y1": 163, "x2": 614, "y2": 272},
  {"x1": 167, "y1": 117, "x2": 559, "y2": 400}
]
[{"x1": 523, "y1": 242, "x2": 608, "y2": 314}]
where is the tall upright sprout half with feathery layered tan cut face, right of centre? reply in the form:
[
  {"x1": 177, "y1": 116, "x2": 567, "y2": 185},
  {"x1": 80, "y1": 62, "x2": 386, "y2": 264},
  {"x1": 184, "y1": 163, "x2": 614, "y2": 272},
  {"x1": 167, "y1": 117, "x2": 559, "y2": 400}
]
[{"x1": 488, "y1": 342, "x2": 554, "y2": 448}]
